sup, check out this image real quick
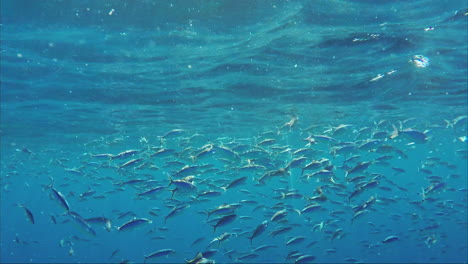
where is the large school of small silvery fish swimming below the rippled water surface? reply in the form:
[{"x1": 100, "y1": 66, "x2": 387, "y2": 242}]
[{"x1": 2, "y1": 116, "x2": 468, "y2": 263}]
